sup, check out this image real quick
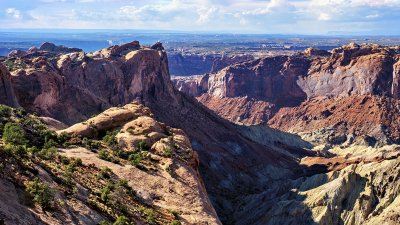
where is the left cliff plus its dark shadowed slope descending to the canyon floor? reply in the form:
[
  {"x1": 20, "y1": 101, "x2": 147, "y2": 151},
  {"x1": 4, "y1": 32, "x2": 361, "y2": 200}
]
[{"x1": 3, "y1": 42, "x2": 303, "y2": 224}]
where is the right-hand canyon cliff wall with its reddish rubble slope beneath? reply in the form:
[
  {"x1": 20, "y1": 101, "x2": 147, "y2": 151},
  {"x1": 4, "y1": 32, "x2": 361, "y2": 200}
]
[{"x1": 179, "y1": 44, "x2": 400, "y2": 143}]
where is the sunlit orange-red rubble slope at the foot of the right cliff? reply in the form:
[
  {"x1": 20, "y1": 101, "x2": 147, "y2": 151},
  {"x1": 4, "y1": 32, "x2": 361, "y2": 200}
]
[{"x1": 269, "y1": 96, "x2": 400, "y2": 146}]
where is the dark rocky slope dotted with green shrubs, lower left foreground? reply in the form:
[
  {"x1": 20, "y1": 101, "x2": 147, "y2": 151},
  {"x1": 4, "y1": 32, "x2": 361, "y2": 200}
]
[{"x1": 0, "y1": 105, "x2": 185, "y2": 225}]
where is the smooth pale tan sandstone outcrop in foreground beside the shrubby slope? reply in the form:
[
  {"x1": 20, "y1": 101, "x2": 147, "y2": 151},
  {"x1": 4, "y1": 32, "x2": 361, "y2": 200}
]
[{"x1": 58, "y1": 102, "x2": 221, "y2": 224}]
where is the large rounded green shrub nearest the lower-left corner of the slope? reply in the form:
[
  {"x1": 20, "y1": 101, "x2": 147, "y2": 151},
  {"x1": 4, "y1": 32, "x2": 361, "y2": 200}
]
[{"x1": 26, "y1": 178, "x2": 54, "y2": 210}]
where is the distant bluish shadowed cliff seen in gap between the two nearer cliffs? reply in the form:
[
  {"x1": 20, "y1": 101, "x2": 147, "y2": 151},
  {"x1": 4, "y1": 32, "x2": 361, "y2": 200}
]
[{"x1": 169, "y1": 52, "x2": 254, "y2": 76}]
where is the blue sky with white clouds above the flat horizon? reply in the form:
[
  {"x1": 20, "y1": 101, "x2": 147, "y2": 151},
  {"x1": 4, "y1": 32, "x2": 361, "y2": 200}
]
[{"x1": 0, "y1": 0, "x2": 400, "y2": 35}]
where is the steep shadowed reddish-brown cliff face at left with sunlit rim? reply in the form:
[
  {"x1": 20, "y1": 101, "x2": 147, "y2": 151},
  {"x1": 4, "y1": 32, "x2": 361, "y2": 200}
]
[{"x1": 8, "y1": 43, "x2": 173, "y2": 124}]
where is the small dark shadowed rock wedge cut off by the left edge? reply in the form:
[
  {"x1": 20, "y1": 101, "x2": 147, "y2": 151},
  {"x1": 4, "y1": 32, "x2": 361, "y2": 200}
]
[{"x1": 0, "y1": 63, "x2": 19, "y2": 107}]
